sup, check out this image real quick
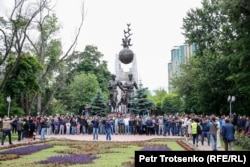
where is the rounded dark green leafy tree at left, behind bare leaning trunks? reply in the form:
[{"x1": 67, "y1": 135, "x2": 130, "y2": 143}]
[{"x1": 1, "y1": 53, "x2": 42, "y2": 115}]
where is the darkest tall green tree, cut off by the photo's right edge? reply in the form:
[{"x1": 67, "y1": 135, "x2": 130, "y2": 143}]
[{"x1": 220, "y1": 0, "x2": 250, "y2": 114}]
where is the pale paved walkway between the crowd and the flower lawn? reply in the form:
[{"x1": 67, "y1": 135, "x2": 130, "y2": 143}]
[{"x1": 0, "y1": 134, "x2": 224, "y2": 151}]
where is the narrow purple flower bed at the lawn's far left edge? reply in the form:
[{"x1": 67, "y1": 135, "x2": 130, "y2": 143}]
[{"x1": 0, "y1": 144, "x2": 53, "y2": 155}]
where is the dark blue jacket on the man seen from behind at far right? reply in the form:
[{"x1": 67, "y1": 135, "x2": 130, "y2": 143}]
[{"x1": 222, "y1": 123, "x2": 235, "y2": 142}]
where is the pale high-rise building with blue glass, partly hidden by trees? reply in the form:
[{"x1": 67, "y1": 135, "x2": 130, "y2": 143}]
[{"x1": 168, "y1": 44, "x2": 195, "y2": 92}]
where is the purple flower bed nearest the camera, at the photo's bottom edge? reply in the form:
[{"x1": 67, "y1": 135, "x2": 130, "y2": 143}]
[{"x1": 38, "y1": 154, "x2": 97, "y2": 165}]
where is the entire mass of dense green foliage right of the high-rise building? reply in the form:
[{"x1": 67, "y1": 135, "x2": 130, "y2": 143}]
[{"x1": 171, "y1": 0, "x2": 250, "y2": 114}]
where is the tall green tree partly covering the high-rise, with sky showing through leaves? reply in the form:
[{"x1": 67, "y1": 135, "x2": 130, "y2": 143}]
[{"x1": 175, "y1": 0, "x2": 243, "y2": 114}]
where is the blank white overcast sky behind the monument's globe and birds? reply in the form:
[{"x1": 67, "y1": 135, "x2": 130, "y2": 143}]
[{"x1": 0, "y1": 0, "x2": 202, "y2": 90}]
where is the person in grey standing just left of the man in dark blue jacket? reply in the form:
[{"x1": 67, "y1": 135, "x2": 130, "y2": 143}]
[{"x1": 209, "y1": 117, "x2": 218, "y2": 151}]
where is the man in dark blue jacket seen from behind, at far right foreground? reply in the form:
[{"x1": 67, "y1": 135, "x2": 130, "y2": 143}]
[{"x1": 222, "y1": 118, "x2": 235, "y2": 151}]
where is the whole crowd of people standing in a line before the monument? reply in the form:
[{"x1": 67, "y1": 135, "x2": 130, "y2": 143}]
[{"x1": 1, "y1": 113, "x2": 250, "y2": 151}]
